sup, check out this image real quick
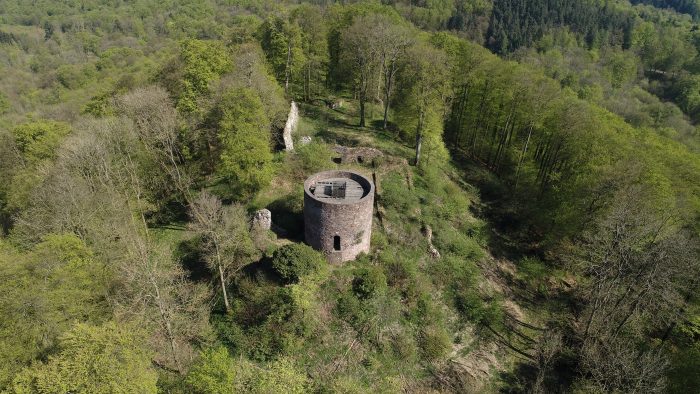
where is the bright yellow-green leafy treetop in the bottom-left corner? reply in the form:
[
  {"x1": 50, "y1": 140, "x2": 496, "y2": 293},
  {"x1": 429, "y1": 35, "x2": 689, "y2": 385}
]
[{"x1": 12, "y1": 323, "x2": 157, "y2": 394}]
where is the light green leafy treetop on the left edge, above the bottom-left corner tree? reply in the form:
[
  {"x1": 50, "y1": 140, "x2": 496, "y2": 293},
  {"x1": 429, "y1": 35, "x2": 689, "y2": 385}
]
[{"x1": 0, "y1": 234, "x2": 109, "y2": 386}]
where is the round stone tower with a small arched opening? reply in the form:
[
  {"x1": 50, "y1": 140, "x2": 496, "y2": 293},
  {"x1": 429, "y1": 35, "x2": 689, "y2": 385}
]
[{"x1": 304, "y1": 171, "x2": 374, "y2": 263}]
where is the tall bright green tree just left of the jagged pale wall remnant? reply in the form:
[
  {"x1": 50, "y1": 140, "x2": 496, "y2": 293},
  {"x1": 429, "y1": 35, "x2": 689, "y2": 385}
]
[{"x1": 217, "y1": 89, "x2": 273, "y2": 195}]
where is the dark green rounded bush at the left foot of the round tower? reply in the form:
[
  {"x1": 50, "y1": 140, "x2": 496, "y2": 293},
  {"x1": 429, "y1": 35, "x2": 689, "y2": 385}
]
[{"x1": 272, "y1": 243, "x2": 324, "y2": 283}]
